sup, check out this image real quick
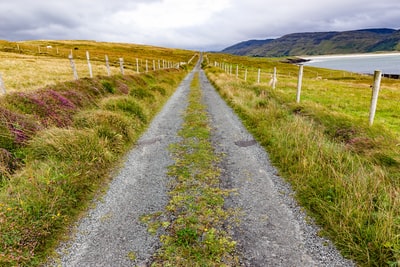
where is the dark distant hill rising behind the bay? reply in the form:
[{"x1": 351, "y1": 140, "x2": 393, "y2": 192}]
[{"x1": 222, "y1": 28, "x2": 400, "y2": 57}]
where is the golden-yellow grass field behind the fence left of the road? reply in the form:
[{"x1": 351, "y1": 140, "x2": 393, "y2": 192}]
[{"x1": 0, "y1": 41, "x2": 194, "y2": 92}]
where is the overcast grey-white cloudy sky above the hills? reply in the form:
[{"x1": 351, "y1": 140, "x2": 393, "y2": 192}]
[{"x1": 0, "y1": 0, "x2": 400, "y2": 50}]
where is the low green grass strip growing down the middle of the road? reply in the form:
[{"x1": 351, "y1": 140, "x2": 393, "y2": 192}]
[{"x1": 143, "y1": 75, "x2": 238, "y2": 266}]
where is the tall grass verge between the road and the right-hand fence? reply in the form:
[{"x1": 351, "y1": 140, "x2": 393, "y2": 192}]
[{"x1": 207, "y1": 68, "x2": 400, "y2": 266}]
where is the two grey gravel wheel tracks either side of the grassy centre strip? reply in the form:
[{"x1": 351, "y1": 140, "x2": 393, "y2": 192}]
[{"x1": 50, "y1": 61, "x2": 354, "y2": 267}]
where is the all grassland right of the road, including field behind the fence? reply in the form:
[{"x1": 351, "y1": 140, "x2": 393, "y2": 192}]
[{"x1": 205, "y1": 54, "x2": 400, "y2": 266}]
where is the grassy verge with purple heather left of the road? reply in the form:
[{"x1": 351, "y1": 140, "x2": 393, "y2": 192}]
[{"x1": 0, "y1": 40, "x2": 193, "y2": 266}]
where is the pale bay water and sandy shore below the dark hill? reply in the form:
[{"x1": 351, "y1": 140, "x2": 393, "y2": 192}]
[{"x1": 302, "y1": 53, "x2": 400, "y2": 74}]
